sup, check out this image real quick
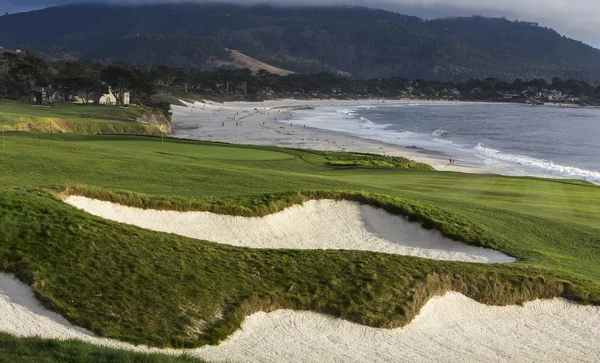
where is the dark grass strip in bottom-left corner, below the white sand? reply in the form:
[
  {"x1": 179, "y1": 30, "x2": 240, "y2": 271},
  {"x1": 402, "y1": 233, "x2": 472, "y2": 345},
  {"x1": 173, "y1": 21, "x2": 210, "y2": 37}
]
[{"x1": 0, "y1": 334, "x2": 203, "y2": 363}]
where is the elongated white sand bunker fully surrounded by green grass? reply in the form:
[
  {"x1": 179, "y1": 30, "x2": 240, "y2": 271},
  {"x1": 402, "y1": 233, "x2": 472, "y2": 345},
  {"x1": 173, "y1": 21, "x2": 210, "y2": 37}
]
[{"x1": 65, "y1": 196, "x2": 515, "y2": 263}]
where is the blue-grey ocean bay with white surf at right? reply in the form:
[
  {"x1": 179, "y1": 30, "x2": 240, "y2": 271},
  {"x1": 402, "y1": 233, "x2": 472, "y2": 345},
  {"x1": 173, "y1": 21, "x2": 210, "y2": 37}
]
[{"x1": 288, "y1": 103, "x2": 600, "y2": 184}]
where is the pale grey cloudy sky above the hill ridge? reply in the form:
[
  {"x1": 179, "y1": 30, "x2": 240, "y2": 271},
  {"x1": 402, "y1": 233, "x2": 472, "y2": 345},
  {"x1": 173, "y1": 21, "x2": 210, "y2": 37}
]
[{"x1": 0, "y1": 0, "x2": 600, "y2": 47}]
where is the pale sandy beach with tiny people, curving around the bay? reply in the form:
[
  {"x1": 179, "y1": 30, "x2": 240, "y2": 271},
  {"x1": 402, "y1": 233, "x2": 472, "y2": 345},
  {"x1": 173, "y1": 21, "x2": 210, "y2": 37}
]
[{"x1": 171, "y1": 100, "x2": 493, "y2": 173}]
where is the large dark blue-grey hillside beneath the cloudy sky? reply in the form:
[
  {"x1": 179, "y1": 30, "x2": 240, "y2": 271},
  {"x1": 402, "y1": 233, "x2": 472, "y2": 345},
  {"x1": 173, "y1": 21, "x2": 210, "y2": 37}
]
[{"x1": 0, "y1": 4, "x2": 600, "y2": 83}]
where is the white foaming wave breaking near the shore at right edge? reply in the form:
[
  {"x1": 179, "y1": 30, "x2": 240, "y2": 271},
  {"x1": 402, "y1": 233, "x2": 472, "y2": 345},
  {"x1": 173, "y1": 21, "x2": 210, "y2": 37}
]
[{"x1": 475, "y1": 143, "x2": 600, "y2": 182}]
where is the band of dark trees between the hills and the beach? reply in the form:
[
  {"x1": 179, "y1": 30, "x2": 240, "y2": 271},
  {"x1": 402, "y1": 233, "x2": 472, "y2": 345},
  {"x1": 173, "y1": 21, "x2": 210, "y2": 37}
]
[{"x1": 0, "y1": 50, "x2": 600, "y2": 110}]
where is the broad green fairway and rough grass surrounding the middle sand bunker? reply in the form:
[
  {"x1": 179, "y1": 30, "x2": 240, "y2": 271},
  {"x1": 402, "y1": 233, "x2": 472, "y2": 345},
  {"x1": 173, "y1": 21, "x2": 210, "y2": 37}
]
[{"x1": 0, "y1": 133, "x2": 600, "y2": 352}]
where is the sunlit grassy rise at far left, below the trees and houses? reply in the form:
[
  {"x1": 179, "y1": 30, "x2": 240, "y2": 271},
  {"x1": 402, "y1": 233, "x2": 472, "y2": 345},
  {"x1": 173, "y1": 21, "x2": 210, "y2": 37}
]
[{"x1": 0, "y1": 100, "x2": 158, "y2": 134}]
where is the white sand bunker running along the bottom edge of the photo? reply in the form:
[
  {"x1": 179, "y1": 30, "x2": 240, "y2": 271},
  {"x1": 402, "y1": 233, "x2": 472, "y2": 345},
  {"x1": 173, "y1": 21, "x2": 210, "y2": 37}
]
[{"x1": 0, "y1": 274, "x2": 600, "y2": 363}]
